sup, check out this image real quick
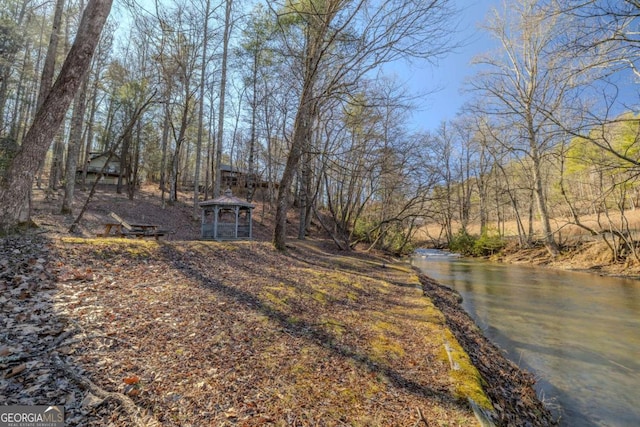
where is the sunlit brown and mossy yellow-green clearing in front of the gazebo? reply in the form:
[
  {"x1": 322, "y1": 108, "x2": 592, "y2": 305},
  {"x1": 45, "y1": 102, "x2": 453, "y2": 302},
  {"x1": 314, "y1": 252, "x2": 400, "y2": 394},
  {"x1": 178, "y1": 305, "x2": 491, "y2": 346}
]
[{"x1": 43, "y1": 239, "x2": 490, "y2": 426}]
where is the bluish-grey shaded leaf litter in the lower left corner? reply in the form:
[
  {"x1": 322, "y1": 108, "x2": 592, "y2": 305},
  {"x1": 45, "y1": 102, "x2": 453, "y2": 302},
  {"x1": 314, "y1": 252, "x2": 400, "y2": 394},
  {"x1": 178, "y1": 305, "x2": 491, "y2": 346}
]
[{"x1": 0, "y1": 234, "x2": 148, "y2": 425}]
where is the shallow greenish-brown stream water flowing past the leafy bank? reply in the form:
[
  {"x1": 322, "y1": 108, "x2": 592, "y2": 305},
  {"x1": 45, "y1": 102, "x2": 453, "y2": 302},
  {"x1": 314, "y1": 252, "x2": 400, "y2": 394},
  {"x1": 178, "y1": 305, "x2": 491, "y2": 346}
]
[{"x1": 412, "y1": 250, "x2": 640, "y2": 427}]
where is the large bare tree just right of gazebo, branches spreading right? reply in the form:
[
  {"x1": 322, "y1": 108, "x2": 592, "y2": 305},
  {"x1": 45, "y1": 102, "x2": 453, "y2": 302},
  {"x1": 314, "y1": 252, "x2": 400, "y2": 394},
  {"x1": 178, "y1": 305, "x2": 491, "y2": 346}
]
[{"x1": 272, "y1": 0, "x2": 453, "y2": 250}]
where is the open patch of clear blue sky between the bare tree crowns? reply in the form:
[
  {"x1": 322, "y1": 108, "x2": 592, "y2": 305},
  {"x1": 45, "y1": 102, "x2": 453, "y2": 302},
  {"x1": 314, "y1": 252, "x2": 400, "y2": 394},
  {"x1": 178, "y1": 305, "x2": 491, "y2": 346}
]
[{"x1": 382, "y1": 0, "x2": 497, "y2": 130}]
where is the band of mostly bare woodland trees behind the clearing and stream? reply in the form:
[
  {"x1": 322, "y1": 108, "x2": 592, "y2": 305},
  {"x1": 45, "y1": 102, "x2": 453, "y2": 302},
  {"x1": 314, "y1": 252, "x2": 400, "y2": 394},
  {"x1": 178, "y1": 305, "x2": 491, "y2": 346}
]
[{"x1": 0, "y1": 0, "x2": 640, "y2": 259}]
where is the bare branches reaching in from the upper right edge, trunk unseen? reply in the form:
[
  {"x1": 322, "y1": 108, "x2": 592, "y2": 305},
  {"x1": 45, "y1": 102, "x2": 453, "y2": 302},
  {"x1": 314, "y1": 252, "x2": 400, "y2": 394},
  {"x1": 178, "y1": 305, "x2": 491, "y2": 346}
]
[{"x1": 557, "y1": 0, "x2": 640, "y2": 168}]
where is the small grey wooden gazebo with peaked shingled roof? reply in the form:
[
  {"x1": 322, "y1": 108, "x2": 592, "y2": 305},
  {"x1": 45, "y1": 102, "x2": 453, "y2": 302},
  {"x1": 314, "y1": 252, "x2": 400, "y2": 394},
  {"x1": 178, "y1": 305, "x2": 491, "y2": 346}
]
[{"x1": 200, "y1": 189, "x2": 255, "y2": 240}]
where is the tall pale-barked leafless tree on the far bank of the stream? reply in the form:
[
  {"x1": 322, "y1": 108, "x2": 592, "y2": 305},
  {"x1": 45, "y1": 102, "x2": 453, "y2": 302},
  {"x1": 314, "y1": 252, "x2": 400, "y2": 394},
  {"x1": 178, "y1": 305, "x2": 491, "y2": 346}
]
[{"x1": 464, "y1": 0, "x2": 574, "y2": 256}]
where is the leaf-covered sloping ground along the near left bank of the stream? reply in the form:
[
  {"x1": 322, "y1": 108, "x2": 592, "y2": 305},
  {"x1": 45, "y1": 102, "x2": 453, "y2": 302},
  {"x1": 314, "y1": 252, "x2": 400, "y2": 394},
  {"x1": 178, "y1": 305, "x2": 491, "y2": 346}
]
[{"x1": 0, "y1": 189, "x2": 553, "y2": 426}]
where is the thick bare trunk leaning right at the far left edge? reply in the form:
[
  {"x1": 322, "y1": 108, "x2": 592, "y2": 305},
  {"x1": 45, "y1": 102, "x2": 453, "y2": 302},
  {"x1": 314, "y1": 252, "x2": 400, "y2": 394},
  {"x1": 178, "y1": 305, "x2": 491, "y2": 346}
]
[{"x1": 0, "y1": 0, "x2": 113, "y2": 233}]
